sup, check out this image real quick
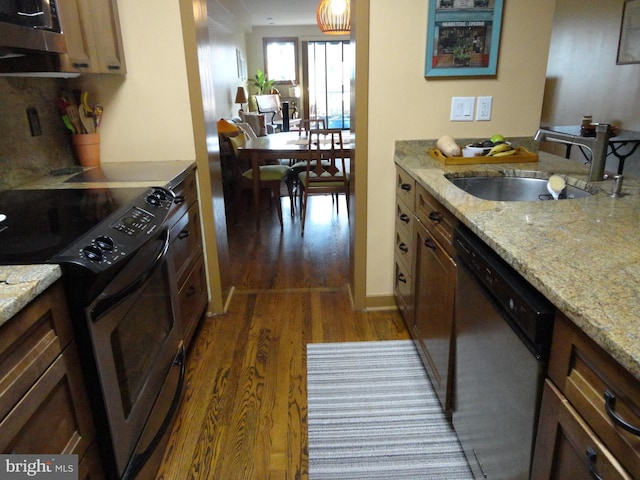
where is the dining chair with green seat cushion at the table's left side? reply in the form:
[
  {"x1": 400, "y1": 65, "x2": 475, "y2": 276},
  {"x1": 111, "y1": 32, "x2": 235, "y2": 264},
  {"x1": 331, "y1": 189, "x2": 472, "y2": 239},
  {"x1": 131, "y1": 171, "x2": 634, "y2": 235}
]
[{"x1": 226, "y1": 132, "x2": 295, "y2": 229}]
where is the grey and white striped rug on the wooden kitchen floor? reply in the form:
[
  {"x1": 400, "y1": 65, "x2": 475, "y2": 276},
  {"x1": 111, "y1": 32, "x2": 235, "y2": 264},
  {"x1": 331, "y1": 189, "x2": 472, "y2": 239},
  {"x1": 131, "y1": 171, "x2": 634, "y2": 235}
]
[{"x1": 307, "y1": 340, "x2": 473, "y2": 480}]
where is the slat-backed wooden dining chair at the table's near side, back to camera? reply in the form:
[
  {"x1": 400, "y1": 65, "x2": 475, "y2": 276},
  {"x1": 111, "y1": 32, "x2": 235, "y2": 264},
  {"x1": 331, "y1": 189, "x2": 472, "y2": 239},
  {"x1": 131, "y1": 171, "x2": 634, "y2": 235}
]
[{"x1": 298, "y1": 128, "x2": 349, "y2": 236}]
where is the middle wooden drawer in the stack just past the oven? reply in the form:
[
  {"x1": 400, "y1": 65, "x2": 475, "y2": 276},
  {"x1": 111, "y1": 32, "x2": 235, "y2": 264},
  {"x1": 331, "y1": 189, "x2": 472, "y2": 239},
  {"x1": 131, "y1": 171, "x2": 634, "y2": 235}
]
[{"x1": 171, "y1": 204, "x2": 202, "y2": 285}]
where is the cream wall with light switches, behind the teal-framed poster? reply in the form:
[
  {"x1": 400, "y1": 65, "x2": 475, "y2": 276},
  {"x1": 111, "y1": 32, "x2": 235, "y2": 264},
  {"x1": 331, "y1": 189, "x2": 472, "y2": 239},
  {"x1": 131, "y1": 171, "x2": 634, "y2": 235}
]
[{"x1": 366, "y1": 0, "x2": 555, "y2": 297}]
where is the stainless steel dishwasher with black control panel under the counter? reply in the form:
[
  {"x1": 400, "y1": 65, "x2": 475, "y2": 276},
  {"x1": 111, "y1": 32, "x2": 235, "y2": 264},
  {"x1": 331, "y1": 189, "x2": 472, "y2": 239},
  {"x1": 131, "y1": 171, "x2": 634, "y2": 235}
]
[{"x1": 452, "y1": 226, "x2": 554, "y2": 480}]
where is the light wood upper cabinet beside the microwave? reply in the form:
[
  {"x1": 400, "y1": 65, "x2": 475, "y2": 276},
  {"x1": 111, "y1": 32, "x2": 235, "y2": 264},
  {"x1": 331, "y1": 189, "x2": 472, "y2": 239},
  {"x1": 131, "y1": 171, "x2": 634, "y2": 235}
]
[{"x1": 58, "y1": 0, "x2": 127, "y2": 74}]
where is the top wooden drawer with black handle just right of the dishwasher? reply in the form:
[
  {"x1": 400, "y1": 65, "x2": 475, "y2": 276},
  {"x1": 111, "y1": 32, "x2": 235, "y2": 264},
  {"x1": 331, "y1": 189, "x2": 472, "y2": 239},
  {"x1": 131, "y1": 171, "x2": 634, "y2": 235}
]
[{"x1": 549, "y1": 314, "x2": 640, "y2": 478}]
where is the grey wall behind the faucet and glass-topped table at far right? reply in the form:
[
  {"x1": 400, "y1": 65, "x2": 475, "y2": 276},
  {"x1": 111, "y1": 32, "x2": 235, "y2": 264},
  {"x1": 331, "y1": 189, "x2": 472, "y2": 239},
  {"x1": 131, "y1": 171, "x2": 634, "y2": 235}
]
[{"x1": 542, "y1": 0, "x2": 640, "y2": 177}]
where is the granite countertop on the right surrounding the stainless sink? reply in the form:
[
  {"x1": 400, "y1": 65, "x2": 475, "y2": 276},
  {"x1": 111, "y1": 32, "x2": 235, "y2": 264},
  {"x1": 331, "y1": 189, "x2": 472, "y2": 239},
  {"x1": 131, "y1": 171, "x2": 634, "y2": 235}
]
[{"x1": 394, "y1": 140, "x2": 640, "y2": 379}]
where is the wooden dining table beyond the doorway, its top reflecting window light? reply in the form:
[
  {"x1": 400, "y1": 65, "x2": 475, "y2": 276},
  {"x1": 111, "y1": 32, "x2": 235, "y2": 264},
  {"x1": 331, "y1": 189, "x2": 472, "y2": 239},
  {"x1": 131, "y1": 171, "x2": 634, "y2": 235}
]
[{"x1": 238, "y1": 130, "x2": 355, "y2": 228}]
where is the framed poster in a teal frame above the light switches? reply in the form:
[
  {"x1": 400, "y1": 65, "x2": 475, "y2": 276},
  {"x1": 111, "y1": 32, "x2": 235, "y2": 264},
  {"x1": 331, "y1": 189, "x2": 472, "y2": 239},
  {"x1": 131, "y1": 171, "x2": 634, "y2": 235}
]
[{"x1": 424, "y1": 0, "x2": 504, "y2": 77}]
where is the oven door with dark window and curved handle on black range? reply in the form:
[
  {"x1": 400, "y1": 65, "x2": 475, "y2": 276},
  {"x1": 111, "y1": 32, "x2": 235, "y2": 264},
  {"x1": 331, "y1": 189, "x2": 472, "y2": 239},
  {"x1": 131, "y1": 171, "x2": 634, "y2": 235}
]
[{"x1": 85, "y1": 228, "x2": 184, "y2": 478}]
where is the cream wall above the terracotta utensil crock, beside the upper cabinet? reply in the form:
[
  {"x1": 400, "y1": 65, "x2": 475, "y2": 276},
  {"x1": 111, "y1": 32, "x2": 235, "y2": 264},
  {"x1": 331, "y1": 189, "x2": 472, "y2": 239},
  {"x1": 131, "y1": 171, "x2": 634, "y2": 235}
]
[{"x1": 70, "y1": 0, "x2": 195, "y2": 162}]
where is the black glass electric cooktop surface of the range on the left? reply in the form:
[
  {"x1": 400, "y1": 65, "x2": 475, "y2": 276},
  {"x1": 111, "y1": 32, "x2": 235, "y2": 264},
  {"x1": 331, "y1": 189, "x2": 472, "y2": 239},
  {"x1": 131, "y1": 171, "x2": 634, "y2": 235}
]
[{"x1": 0, "y1": 187, "x2": 149, "y2": 265}]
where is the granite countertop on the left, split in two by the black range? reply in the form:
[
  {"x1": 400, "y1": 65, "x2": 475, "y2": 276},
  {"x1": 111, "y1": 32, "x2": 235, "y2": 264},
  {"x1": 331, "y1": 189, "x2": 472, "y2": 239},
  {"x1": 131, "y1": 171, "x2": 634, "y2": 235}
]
[{"x1": 0, "y1": 160, "x2": 195, "y2": 326}]
